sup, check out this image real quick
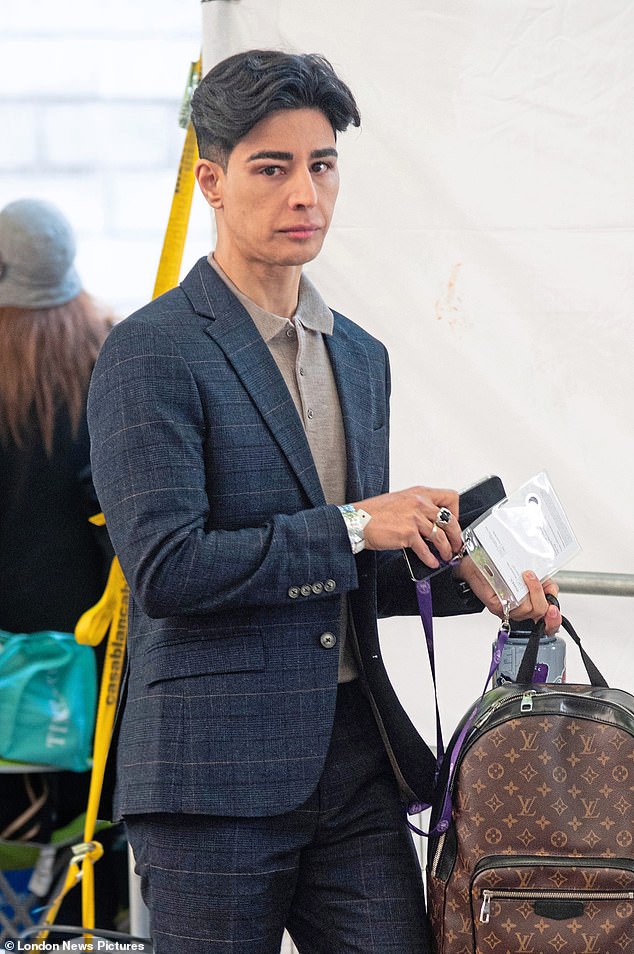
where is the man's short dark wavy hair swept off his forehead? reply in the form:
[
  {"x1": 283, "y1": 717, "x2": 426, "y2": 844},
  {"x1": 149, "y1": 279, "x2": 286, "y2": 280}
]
[{"x1": 192, "y1": 50, "x2": 361, "y2": 168}]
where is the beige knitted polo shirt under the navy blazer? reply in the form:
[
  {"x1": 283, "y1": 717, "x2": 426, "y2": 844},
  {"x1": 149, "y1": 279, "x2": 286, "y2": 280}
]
[{"x1": 209, "y1": 254, "x2": 359, "y2": 682}]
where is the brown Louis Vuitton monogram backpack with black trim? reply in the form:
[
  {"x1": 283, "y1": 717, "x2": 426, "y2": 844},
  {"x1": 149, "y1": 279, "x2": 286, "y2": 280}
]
[{"x1": 428, "y1": 687, "x2": 634, "y2": 954}]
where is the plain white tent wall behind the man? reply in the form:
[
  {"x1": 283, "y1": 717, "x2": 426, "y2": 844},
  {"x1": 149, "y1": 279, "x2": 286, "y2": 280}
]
[{"x1": 202, "y1": 0, "x2": 634, "y2": 738}]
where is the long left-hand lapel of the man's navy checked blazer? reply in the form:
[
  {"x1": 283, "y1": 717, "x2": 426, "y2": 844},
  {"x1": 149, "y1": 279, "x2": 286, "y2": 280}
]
[{"x1": 181, "y1": 258, "x2": 325, "y2": 506}]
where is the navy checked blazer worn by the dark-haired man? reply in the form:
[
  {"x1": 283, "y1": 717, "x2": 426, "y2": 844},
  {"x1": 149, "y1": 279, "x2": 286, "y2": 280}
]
[{"x1": 88, "y1": 258, "x2": 480, "y2": 817}]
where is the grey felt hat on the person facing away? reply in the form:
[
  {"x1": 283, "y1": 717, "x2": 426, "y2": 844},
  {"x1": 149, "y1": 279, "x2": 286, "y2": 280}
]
[{"x1": 0, "y1": 199, "x2": 81, "y2": 308}]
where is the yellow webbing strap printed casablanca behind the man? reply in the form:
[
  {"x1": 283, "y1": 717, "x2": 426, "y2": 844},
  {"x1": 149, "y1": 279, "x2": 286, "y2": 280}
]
[{"x1": 37, "y1": 59, "x2": 202, "y2": 944}]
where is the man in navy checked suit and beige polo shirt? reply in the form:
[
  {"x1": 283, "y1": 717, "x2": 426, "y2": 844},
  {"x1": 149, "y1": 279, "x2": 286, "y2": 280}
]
[{"x1": 89, "y1": 51, "x2": 558, "y2": 954}]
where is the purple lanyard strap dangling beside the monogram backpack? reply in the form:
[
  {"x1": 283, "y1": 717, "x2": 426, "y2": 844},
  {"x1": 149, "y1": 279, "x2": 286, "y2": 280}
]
[{"x1": 407, "y1": 579, "x2": 509, "y2": 838}]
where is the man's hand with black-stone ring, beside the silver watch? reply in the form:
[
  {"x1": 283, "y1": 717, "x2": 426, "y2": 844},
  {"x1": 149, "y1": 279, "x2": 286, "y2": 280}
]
[{"x1": 354, "y1": 487, "x2": 462, "y2": 569}]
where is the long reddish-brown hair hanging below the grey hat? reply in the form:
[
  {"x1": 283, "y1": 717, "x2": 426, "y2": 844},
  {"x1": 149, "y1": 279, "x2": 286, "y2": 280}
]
[{"x1": 0, "y1": 291, "x2": 113, "y2": 456}]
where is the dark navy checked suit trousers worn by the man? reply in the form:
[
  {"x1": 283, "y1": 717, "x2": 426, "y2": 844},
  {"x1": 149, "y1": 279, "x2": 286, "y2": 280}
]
[{"x1": 126, "y1": 682, "x2": 429, "y2": 954}]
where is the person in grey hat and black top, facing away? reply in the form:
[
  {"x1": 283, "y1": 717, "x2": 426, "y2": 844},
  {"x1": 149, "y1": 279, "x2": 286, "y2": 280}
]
[{"x1": 0, "y1": 198, "x2": 126, "y2": 928}]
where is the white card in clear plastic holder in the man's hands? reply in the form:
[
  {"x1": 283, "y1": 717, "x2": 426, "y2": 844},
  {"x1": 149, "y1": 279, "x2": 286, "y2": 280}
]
[{"x1": 462, "y1": 472, "x2": 581, "y2": 609}]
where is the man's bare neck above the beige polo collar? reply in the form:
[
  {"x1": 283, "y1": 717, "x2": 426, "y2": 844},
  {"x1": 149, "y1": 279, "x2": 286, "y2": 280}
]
[{"x1": 214, "y1": 249, "x2": 302, "y2": 318}]
